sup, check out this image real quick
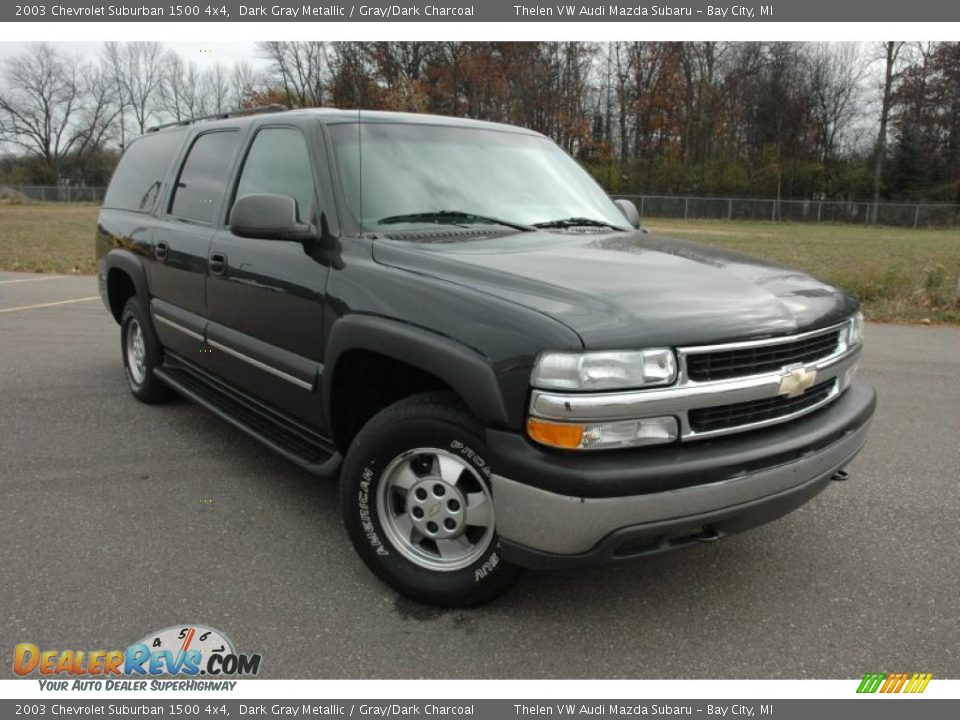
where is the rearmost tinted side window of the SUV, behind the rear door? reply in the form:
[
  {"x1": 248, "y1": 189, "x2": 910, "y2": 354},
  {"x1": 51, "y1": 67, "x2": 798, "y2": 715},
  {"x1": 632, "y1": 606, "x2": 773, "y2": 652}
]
[{"x1": 103, "y1": 132, "x2": 183, "y2": 212}]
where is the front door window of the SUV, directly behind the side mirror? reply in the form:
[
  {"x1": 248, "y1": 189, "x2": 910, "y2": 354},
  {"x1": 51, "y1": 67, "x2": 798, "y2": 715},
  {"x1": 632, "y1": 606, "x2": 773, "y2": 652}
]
[{"x1": 236, "y1": 128, "x2": 314, "y2": 222}]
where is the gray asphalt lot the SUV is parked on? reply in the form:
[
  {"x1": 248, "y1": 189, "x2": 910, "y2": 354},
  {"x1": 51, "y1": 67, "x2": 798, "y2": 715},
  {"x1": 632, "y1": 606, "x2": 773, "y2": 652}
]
[{"x1": 0, "y1": 273, "x2": 960, "y2": 679}]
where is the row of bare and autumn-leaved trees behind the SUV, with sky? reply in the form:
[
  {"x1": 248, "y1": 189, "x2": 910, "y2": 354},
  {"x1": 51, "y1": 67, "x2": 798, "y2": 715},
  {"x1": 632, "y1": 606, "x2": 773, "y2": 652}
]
[{"x1": 0, "y1": 41, "x2": 960, "y2": 203}]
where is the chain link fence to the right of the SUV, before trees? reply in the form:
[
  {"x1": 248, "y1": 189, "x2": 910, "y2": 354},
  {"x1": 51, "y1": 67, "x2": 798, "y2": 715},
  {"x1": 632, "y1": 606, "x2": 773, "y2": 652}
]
[{"x1": 614, "y1": 195, "x2": 960, "y2": 228}]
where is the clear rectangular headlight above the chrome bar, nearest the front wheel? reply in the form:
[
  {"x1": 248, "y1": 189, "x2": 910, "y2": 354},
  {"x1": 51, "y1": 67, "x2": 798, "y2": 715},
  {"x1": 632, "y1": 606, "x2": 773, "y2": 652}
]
[{"x1": 530, "y1": 348, "x2": 677, "y2": 390}]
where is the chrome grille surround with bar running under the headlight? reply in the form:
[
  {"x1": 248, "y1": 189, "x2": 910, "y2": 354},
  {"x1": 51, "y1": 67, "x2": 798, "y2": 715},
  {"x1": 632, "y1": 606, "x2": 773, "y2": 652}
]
[{"x1": 530, "y1": 336, "x2": 862, "y2": 440}]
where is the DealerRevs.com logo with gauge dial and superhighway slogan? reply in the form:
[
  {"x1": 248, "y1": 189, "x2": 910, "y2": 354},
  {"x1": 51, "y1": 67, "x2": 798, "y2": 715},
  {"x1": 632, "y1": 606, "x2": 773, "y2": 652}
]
[{"x1": 13, "y1": 625, "x2": 260, "y2": 690}]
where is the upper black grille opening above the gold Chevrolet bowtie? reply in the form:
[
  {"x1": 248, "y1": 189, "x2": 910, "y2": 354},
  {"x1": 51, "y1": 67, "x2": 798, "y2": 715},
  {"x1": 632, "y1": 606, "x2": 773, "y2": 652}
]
[{"x1": 687, "y1": 330, "x2": 840, "y2": 382}]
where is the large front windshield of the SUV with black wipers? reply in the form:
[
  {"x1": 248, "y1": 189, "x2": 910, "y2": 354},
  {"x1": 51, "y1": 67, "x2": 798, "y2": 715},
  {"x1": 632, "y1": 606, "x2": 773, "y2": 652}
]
[{"x1": 329, "y1": 123, "x2": 628, "y2": 230}]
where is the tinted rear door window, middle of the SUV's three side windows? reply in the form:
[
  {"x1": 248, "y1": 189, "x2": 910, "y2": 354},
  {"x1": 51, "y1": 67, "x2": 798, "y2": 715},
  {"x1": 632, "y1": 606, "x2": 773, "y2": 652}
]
[{"x1": 170, "y1": 130, "x2": 240, "y2": 223}]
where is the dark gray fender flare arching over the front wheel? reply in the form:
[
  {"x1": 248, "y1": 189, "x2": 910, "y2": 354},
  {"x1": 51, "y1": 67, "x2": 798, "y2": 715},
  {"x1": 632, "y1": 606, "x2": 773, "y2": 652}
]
[{"x1": 321, "y1": 314, "x2": 508, "y2": 430}]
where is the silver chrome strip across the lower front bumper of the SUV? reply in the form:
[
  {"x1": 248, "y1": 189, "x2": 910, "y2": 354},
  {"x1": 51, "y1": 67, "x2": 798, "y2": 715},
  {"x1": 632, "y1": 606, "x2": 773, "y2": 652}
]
[{"x1": 492, "y1": 422, "x2": 870, "y2": 555}]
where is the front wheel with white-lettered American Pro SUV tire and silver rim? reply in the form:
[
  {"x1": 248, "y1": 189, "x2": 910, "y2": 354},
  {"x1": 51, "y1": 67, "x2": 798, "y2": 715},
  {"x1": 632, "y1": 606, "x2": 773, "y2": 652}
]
[{"x1": 340, "y1": 393, "x2": 520, "y2": 607}]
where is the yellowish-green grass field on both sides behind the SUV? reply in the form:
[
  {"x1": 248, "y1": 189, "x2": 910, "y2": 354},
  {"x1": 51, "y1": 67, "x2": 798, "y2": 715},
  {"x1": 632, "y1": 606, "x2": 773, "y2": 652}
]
[{"x1": 0, "y1": 203, "x2": 960, "y2": 325}]
